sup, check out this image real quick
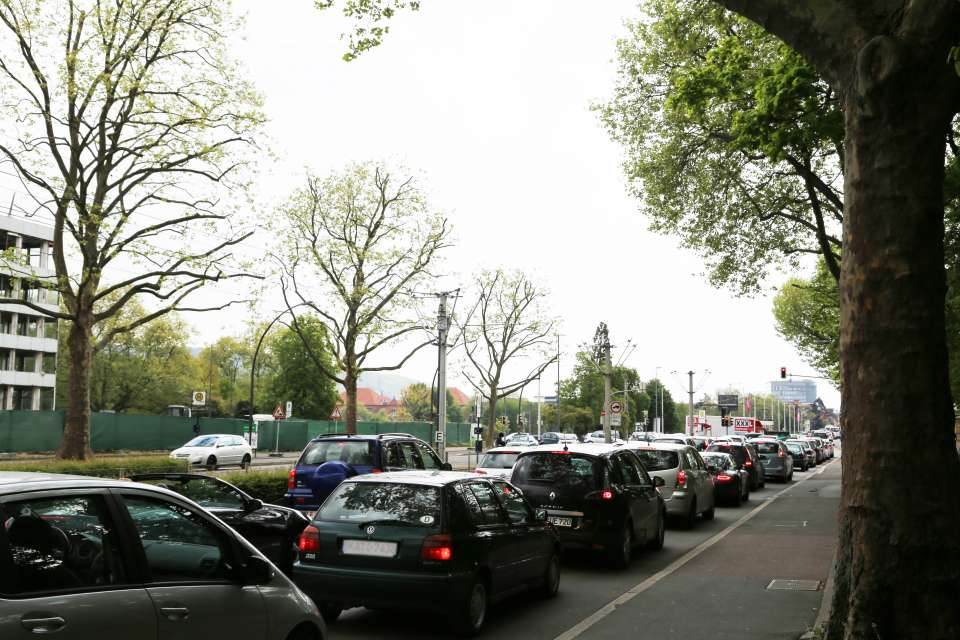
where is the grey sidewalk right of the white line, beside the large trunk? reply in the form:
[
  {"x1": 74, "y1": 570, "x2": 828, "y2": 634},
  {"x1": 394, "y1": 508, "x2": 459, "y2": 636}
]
[{"x1": 561, "y1": 460, "x2": 840, "y2": 640}]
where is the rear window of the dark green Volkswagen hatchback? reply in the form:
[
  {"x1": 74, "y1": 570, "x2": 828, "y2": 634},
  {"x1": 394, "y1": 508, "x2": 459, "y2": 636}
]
[{"x1": 316, "y1": 482, "x2": 440, "y2": 528}]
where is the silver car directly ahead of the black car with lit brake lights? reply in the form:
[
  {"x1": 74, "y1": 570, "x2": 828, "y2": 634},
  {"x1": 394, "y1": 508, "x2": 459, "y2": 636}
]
[{"x1": 626, "y1": 442, "x2": 714, "y2": 527}]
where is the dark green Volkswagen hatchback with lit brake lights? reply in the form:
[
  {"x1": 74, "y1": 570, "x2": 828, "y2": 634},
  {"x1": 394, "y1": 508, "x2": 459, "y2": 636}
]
[{"x1": 293, "y1": 471, "x2": 560, "y2": 635}]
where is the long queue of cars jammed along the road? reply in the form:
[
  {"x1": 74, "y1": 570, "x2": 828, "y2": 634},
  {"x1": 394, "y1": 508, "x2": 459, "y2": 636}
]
[{"x1": 0, "y1": 428, "x2": 840, "y2": 640}]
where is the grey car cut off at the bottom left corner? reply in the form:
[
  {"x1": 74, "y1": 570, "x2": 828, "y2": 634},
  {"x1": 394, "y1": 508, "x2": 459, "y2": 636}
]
[{"x1": 0, "y1": 472, "x2": 326, "y2": 640}]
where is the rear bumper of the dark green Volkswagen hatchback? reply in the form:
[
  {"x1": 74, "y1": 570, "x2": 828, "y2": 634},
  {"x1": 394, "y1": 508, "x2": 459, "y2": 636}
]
[{"x1": 291, "y1": 562, "x2": 473, "y2": 613}]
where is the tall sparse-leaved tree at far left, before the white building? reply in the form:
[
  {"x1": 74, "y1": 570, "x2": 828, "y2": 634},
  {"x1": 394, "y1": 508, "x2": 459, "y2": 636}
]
[{"x1": 0, "y1": 0, "x2": 263, "y2": 459}]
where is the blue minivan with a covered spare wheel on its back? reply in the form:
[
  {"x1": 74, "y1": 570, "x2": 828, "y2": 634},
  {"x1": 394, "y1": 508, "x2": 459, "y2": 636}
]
[{"x1": 282, "y1": 433, "x2": 451, "y2": 512}]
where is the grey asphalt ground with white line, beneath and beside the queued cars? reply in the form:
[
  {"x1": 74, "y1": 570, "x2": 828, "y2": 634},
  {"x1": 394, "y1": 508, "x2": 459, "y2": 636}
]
[{"x1": 330, "y1": 460, "x2": 840, "y2": 640}]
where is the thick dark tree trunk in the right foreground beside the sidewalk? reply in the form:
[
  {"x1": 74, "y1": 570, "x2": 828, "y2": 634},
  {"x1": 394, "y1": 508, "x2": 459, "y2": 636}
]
[{"x1": 828, "y1": 37, "x2": 960, "y2": 640}]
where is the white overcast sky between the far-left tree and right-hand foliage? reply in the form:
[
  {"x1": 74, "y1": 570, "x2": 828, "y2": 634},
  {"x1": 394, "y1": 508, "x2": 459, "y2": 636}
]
[{"x1": 0, "y1": 0, "x2": 839, "y2": 407}]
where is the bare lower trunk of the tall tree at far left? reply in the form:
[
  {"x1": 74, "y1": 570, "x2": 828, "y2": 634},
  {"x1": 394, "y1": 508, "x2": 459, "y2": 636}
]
[{"x1": 57, "y1": 314, "x2": 93, "y2": 460}]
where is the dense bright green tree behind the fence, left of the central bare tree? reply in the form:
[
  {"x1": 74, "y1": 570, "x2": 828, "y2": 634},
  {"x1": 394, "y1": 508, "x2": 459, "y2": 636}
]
[{"x1": 260, "y1": 316, "x2": 339, "y2": 420}]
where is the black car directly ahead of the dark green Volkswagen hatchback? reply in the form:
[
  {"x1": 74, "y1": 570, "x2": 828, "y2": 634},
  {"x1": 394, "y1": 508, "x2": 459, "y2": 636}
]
[{"x1": 511, "y1": 444, "x2": 666, "y2": 567}]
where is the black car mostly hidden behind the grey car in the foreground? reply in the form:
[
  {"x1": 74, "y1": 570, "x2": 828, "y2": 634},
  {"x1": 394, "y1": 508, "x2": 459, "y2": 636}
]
[{"x1": 130, "y1": 473, "x2": 310, "y2": 574}]
